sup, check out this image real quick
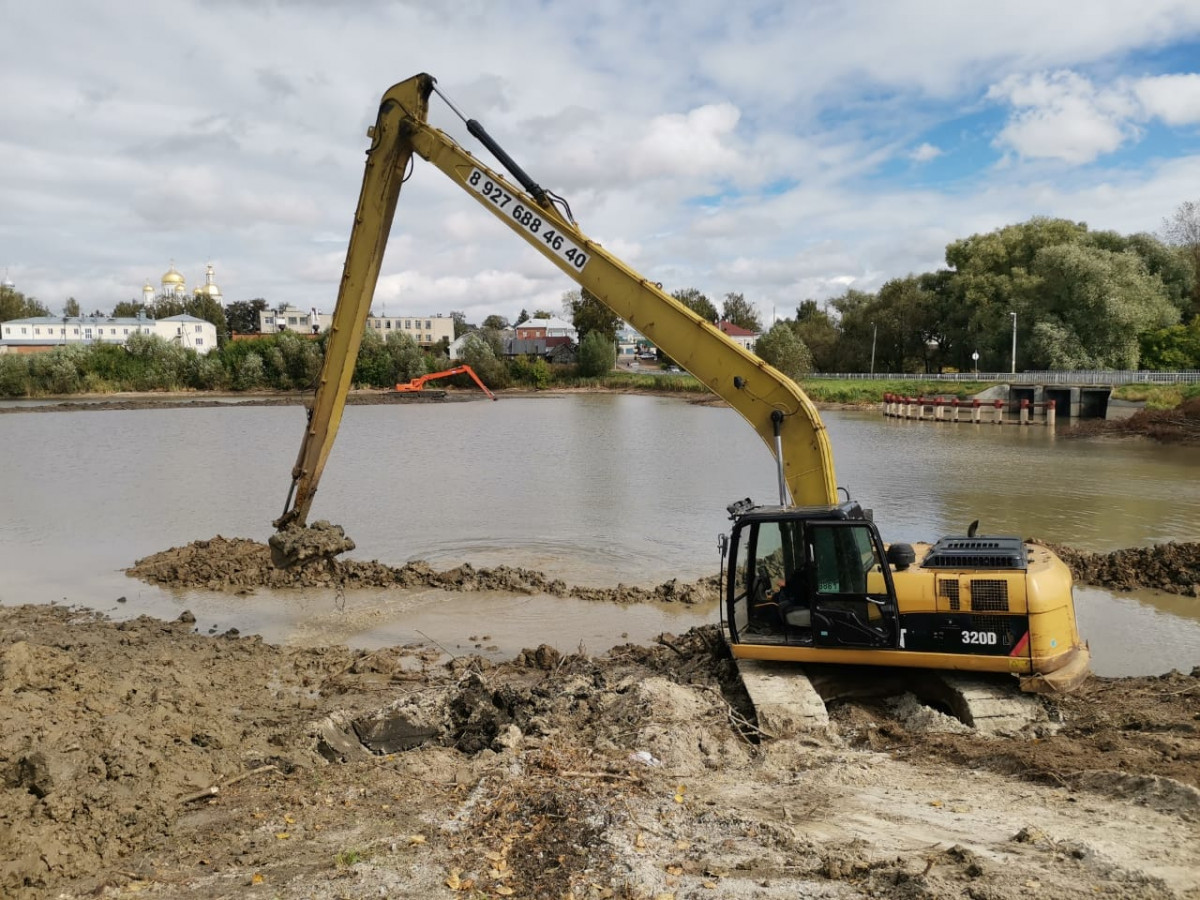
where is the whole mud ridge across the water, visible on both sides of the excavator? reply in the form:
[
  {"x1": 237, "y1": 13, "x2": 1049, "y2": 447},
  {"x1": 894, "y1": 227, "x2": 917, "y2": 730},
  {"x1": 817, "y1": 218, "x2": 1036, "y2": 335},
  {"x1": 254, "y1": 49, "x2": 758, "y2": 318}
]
[{"x1": 126, "y1": 535, "x2": 1200, "y2": 604}]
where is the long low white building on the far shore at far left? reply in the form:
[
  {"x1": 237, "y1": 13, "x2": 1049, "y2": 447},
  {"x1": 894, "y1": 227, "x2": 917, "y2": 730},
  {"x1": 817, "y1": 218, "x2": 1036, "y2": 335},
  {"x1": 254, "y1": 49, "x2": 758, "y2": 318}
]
[{"x1": 0, "y1": 316, "x2": 217, "y2": 353}]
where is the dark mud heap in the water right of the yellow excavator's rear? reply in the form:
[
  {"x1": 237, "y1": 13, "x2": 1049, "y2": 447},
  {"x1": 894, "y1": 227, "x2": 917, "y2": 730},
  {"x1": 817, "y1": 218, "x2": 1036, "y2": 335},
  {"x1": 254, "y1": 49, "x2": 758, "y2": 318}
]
[{"x1": 1045, "y1": 541, "x2": 1200, "y2": 596}]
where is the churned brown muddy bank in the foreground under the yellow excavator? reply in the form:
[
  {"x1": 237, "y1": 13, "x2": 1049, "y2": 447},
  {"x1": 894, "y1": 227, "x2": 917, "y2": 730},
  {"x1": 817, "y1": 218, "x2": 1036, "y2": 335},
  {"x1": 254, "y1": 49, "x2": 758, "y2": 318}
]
[{"x1": 0, "y1": 606, "x2": 1200, "y2": 900}]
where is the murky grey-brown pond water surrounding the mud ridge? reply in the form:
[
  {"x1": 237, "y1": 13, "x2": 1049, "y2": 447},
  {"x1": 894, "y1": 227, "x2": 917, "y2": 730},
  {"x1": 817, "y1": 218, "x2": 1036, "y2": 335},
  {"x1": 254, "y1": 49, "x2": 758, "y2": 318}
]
[{"x1": 0, "y1": 395, "x2": 1200, "y2": 674}]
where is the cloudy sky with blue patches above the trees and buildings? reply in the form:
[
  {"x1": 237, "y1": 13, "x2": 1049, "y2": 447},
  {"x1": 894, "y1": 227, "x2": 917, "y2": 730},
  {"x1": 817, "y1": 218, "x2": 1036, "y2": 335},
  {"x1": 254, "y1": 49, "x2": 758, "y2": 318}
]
[{"x1": 0, "y1": 0, "x2": 1200, "y2": 323}]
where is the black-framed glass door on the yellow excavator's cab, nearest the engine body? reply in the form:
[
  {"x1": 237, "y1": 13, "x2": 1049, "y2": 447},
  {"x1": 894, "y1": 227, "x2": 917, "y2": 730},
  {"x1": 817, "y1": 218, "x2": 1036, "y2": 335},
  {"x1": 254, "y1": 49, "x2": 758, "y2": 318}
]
[{"x1": 806, "y1": 521, "x2": 900, "y2": 649}]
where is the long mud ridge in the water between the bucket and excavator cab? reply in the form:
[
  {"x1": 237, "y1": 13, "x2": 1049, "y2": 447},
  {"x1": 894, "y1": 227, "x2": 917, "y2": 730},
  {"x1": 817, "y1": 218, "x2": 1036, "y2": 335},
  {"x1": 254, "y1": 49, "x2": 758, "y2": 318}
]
[{"x1": 126, "y1": 535, "x2": 719, "y2": 604}]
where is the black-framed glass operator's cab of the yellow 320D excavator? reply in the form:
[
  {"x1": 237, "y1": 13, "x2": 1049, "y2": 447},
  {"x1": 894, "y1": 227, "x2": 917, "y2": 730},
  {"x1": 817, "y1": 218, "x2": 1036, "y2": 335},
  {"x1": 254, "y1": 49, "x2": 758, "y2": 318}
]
[{"x1": 725, "y1": 503, "x2": 900, "y2": 649}]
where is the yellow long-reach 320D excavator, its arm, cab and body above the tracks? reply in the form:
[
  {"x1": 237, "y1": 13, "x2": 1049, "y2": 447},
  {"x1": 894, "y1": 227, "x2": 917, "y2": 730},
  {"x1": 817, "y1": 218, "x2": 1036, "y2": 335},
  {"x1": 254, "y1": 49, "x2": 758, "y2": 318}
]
[{"x1": 272, "y1": 74, "x2": 1088, "y2": 691}]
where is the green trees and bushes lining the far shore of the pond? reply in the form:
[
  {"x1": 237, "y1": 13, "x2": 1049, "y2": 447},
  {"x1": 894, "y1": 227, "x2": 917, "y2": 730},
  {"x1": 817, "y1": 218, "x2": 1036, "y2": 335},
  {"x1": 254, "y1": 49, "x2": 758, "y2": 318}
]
[{"x1": 0, "y1": 202, "x2": 1200, "y2": 396}]
